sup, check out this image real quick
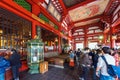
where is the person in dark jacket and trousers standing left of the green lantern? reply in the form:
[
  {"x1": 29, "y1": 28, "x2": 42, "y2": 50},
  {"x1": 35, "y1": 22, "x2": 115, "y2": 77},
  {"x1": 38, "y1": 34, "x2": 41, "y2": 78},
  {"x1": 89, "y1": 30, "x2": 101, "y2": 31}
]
[{"x1": 9, "y1": 49, "x2": 21, "y2": 80}]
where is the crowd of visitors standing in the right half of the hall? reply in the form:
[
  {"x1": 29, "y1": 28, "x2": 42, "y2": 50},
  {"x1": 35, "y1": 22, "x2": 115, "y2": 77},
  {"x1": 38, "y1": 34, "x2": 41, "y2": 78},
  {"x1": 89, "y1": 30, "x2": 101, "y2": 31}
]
[{"x1": 69, "y1": 46, "x2": 120, "y2": 80}]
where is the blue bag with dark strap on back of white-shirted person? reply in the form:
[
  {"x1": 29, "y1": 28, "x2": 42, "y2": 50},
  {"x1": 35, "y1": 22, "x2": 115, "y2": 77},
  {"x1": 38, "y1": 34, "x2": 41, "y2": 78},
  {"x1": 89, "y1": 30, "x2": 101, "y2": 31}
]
[{"x1": 101, "y1": 56, "x2": 118, "y2": 78}]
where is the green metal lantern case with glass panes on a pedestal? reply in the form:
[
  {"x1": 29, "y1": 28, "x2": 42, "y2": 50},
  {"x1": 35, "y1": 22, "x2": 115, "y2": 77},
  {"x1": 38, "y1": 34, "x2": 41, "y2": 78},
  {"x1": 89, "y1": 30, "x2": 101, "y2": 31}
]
[{"x1": 27, "y1": 39, "x2": 44, "y2": 74}]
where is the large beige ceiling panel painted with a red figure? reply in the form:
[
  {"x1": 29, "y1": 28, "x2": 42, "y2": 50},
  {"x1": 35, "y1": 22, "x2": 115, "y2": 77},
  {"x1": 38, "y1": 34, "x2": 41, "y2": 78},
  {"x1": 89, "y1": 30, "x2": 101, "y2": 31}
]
[{"x1": 68, "y1": 0, "x2": 109, "y2": 22}]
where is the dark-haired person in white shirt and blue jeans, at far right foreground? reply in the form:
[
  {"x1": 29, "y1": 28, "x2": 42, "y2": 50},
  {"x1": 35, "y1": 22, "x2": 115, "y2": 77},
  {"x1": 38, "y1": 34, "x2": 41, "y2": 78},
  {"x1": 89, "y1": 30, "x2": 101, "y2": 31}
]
[{"x1": 96, "y1": 47, "x2": 115, "y2": 80}]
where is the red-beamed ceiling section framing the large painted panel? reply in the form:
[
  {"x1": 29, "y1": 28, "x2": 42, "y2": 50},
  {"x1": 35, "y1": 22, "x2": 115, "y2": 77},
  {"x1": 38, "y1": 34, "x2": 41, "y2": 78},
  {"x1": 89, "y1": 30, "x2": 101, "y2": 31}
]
[{"x1": 51, "y1": 0, "x2": 119, "y2": 29}]
